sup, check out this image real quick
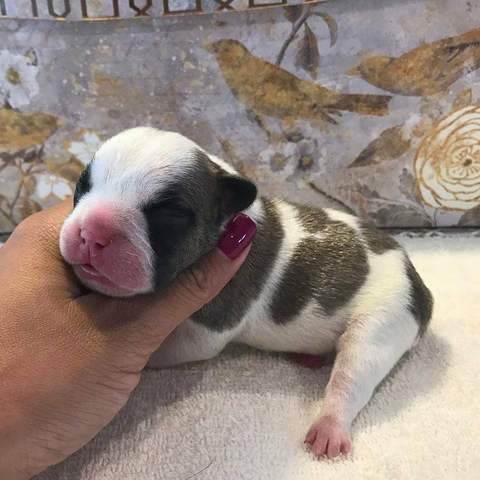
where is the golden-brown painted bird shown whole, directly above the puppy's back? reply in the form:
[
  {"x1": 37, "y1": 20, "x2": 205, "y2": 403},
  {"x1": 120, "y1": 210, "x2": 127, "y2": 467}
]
[{"x1": 206, "y1": 39, "x2": 392, "y2": 123}]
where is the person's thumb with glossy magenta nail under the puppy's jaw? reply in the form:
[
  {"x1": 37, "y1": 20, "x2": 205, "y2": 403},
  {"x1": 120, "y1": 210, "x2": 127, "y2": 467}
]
[{"x1": 79, "y1": 214, "x2": 256, "y2": 363}]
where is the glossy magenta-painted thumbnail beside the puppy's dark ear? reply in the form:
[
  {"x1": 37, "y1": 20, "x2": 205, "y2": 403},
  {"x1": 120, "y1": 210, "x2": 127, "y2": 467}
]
[{"x1": 218, "y1": 213, "x2": 257, "y2": 260}]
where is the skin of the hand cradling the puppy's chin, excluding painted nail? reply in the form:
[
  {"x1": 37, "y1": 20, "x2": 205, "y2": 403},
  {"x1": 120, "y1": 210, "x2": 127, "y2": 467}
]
[{"x1": 0, "y1": 200, "x2": 255, "y2": 480}]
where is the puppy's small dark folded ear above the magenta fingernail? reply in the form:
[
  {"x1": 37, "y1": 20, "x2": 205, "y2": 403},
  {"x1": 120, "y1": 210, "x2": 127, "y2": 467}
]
[{"x1": 219, "y1": 173, "x2": 257, "y2": 217}]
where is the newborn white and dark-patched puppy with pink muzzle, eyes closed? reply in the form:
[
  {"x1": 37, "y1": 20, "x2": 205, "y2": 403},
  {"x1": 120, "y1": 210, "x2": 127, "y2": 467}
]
[{"x1": 60, "y1": 128, "x2": 432, "y2": 457}]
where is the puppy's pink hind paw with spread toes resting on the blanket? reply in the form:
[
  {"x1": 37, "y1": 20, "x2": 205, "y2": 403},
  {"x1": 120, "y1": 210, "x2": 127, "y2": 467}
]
[{"x1": 305, "y1": 415, "x2": 352, "y2": 458}]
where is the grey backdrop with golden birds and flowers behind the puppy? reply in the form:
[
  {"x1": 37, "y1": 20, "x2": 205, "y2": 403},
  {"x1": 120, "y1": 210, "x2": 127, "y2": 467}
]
[{"x1": 0, "y1": 0, "x2": 480, "y2": 233}]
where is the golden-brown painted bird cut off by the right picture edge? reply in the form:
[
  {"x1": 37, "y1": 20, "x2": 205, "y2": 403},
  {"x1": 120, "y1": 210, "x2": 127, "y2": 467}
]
[{"x1": 347, "y1": 28, "x2": 480, "y2": 96}]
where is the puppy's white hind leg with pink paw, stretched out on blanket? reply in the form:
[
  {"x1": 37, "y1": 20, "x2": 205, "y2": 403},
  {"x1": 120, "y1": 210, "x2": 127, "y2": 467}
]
[{"x1": 305, "y1": 312, "x2": 418, "y2": 458}]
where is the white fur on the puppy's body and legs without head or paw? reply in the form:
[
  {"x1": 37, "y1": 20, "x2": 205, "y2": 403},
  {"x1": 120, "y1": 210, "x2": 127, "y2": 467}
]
[{"x1": 150, "y1": 189, "x2": 418, "y2": 444}]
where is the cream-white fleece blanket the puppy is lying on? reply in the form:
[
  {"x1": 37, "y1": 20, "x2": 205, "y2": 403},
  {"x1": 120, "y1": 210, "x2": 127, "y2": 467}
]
[{"x1": 31, "y1": 233, "x2": 480, "y2": 480}]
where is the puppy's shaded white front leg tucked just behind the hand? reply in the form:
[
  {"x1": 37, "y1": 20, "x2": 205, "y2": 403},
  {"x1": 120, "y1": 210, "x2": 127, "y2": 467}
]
[{"x1": 147, "y1": 320, "x2": 234, "y2": 368}]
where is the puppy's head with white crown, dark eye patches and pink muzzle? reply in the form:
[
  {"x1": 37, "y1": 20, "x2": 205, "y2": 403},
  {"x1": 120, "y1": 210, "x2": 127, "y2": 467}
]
[{"x1": 60, "y1": 127, "x2": 257, "y2": 297}]
